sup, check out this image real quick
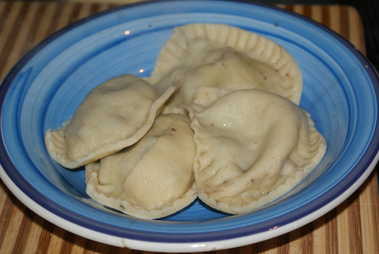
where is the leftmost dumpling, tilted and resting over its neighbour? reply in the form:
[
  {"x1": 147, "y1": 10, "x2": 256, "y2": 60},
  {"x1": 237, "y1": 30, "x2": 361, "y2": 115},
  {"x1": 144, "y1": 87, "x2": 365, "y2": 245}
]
[{"x1": 45, "y1": 75, "x2": 175, "y2": 168}]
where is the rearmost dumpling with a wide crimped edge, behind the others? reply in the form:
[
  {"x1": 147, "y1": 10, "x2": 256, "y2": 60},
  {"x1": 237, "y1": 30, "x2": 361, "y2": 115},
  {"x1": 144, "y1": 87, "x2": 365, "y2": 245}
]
[{"x1": 149, "y1": 24, "x2": 302, "y2": 106}]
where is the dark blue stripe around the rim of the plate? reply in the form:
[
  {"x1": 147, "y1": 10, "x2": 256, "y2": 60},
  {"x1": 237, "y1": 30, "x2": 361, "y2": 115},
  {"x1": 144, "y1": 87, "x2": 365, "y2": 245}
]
[{"x1": 0, "y1": 1, "x2": 379, "y2": 242}]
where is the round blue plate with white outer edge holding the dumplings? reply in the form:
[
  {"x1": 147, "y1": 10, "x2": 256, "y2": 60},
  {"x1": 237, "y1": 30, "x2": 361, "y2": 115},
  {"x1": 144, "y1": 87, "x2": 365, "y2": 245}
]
[{"x1": 0, "y1": 1, "x2": 379, "y2": 251}]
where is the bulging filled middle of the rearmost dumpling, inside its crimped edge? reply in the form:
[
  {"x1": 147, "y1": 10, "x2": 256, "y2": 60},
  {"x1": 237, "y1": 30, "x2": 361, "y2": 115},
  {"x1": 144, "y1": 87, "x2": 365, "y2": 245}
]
[{"x1": 157, "y1": 48, "x2": 294, "y2": 108}]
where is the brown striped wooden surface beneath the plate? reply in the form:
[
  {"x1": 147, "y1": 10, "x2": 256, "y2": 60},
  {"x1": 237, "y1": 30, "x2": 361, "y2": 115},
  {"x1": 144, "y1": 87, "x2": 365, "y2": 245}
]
[{"x1": 0, "y1": 0, "x2": 379, "y2": 254}]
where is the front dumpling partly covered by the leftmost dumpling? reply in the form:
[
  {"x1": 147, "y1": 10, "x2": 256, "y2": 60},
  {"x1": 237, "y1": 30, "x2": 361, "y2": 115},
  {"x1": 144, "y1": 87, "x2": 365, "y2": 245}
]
[{"x1": 86, "y1": 114, "x2": 197, "y2": 219}]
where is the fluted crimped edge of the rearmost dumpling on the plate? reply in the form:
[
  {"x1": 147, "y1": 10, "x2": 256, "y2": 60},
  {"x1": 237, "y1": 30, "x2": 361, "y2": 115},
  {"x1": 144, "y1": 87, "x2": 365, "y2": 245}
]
[{"x1": 148, "y1": 24, "x2": 303, "y2": 104}]
